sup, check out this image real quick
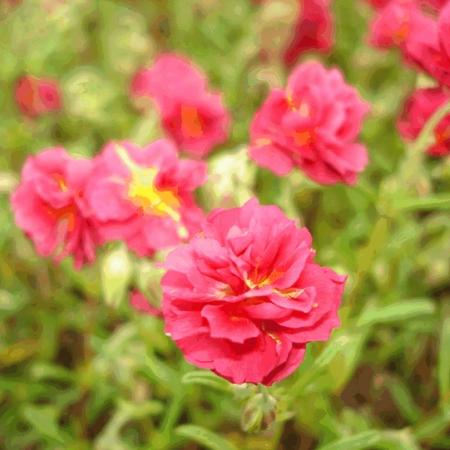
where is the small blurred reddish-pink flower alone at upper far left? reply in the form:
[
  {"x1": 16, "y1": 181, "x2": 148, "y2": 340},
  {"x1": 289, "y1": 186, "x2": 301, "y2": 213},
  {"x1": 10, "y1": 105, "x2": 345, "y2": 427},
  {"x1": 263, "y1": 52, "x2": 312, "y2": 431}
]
[{"x1": 15, "y1": 75, "x2": 62, "y2": 117}]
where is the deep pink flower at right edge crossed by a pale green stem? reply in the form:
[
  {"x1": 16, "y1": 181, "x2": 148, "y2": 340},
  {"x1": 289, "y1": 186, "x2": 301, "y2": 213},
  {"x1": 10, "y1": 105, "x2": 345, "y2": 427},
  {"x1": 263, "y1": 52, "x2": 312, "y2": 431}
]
[{"x1": 398, "y1": 88, "x2": 450, "y2": 156}]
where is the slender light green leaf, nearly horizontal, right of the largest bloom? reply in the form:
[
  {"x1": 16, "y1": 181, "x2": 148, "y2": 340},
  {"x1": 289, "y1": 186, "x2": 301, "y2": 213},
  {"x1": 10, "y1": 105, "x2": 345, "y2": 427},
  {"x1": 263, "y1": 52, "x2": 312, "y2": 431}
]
[{"x1": 357, "y1": 299, "x2": 436, "y2": 327}]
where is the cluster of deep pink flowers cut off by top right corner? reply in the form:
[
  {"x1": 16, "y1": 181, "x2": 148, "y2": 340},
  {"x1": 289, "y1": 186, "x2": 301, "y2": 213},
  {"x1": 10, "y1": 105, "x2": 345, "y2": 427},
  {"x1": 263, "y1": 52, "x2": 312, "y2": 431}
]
[{"x1": 371, "y1": 0, "x2": 450, "y2": 156}]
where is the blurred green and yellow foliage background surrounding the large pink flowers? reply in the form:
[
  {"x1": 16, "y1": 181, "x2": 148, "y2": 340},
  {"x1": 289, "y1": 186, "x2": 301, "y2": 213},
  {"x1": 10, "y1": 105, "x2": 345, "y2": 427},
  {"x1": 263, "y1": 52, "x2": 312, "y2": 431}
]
[{"x1": 0, "y1": 0, "x2": 450, "y2": 450}]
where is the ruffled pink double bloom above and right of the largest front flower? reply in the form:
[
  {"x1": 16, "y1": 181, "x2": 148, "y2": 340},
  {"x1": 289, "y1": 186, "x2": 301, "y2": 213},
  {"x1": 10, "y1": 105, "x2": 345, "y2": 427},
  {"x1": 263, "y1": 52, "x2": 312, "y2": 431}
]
[{"x1": 250, "y1": 62, "x2": 368, "y2": 184}]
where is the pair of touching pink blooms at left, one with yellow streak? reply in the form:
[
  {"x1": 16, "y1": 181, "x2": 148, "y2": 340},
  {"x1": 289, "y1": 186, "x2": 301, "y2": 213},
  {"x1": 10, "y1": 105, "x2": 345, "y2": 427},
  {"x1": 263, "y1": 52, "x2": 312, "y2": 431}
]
[{"x1": 12, "y1": 140, "x2": 206, "y2": 267}]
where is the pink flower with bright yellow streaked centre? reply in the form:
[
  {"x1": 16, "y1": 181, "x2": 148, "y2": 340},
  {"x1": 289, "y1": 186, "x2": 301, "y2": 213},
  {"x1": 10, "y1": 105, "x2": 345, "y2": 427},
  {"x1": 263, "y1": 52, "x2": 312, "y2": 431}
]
[{"x1": 86, "y1": 140, "x2": 206, "y2": 256}]
